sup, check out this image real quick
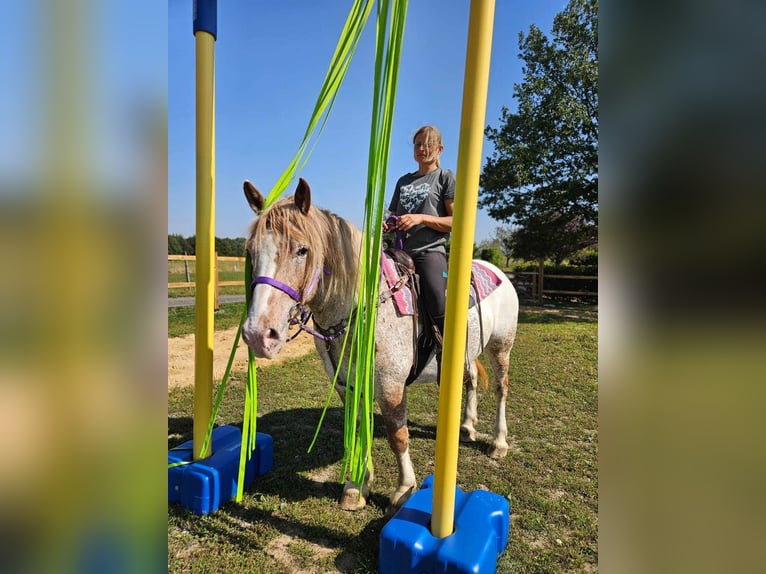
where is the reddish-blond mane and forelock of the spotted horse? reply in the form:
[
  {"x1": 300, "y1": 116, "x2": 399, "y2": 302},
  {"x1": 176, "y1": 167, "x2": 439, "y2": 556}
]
[{"x1": 248, "y1": 196, "x2": 361, "y2": 304}]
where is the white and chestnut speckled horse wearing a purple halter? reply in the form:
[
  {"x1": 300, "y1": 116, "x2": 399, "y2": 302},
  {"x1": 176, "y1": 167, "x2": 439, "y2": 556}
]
[{"x1": 242, "y1": 178, "x2": 519, "y2": 510}]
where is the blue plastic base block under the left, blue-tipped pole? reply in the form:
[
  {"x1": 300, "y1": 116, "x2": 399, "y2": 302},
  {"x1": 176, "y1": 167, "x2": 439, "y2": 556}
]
[{"x1": 168, "y1": 425, "x2": 274, "y2": 514}]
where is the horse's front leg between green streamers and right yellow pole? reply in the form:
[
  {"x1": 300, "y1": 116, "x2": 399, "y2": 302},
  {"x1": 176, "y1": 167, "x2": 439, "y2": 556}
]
[{"x1": 378, "y1": 383, "x2": 417, "y2": 509}]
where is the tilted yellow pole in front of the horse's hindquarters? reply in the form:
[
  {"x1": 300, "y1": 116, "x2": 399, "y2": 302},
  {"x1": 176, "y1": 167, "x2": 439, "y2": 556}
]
[{"x1": 431, "y1": 0, "x2": 495, "y2": 538}]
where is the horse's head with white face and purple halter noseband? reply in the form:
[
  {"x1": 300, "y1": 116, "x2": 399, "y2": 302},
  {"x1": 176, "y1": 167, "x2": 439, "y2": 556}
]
[{"x1": 242, "y1": 178, "x2": 324, "y2": 359}]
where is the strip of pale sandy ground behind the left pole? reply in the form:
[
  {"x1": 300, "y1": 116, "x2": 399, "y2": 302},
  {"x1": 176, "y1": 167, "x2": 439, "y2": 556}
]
[{"x1": 168, "y1": 328, "x2": 314, "y2": 388}]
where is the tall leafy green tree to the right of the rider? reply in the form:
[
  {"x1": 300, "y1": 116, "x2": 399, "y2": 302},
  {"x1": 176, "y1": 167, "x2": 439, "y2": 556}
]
[{"x1": 479, "y1": 0, "x2": 598, "y2": 260}]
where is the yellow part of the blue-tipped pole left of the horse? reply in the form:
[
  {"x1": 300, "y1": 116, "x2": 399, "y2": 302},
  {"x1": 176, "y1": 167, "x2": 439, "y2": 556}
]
[{"x1": 193, "y1": 30, "x2": 215, "y2": 460}]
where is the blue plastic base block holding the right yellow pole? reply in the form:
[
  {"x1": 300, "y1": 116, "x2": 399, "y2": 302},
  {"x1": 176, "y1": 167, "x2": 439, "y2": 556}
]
[{"x1": 378, "y1": 475, "x2": 510, "y2": 574}]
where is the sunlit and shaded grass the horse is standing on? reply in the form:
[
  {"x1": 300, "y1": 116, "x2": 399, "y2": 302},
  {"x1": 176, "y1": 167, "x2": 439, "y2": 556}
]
[{"x1": 168, "y1": 305, "x2": 598, "y2": 573}]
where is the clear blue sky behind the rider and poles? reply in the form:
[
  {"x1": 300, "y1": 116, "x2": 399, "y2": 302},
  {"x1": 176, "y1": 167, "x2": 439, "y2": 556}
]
[{"x1": 168, "y1": 0, "x2": 566, "y2": 241}]
